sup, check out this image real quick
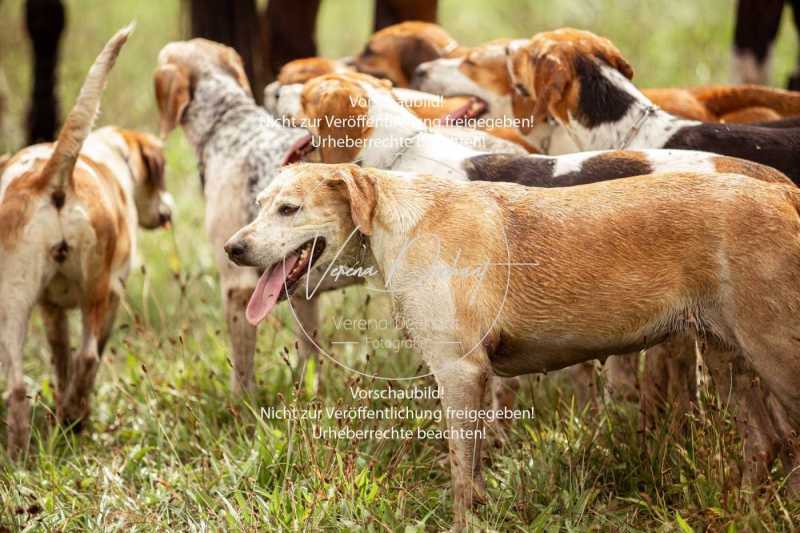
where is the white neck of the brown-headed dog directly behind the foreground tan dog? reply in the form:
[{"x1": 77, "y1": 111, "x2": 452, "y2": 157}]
[{"x1": 356, "y1": 91, "x2": 483, "y2": 179}]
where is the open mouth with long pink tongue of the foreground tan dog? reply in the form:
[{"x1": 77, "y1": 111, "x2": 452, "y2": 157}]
[{"x1": 245, "y1": 237, "x2": 325, "y2": 326}]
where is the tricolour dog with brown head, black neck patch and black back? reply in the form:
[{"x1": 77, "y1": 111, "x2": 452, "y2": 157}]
[{"x1": 509, "y1": 28, "x2": 800, "y2": 183}]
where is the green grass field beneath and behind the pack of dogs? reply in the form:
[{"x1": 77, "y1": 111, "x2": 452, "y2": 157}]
[{"x1": 0, "y1": 0, "x2": 800, "y2": 531}]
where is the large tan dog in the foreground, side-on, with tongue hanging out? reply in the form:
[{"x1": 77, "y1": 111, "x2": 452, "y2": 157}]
[{"x1": 226, "y1": 164, "x2": 800, "y2": 528}]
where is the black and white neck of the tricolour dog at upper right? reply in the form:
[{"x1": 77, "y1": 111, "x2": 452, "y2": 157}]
[{"x1": 560, "y1": 60, "x2": 699, "y2": 151}]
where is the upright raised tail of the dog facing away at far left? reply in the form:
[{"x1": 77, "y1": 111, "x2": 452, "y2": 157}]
[{"x1": 39, "y1": 24, "x2": 133, "y2": 192}]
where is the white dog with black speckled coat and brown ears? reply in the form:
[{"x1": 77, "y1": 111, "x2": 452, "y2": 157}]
[{"x1": 154, "y1": 39, "x2": 317, "y2": 392}]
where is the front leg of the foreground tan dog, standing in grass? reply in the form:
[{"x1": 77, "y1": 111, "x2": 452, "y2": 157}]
[{"x1": 434, "y1": 354, "x2": 489, "y2": 529}]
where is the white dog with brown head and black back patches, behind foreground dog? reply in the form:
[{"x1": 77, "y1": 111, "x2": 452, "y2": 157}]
[{"x1": 264, "y1": 70, "x2": 791, "y2": 426}]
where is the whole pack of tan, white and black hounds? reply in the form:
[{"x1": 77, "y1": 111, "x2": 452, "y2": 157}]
[{"x1": 0, "y1": 18, "x2": 800, "y2": 528}]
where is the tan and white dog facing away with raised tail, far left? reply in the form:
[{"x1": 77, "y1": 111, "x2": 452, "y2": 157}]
[{"x1": 0, "y1": 27, "x2": 171, "y2": 455}]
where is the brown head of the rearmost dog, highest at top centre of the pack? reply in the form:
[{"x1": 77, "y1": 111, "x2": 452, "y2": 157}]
[{"x1": 352, "y1": 21, "x2": 465, "y2": 87}]
